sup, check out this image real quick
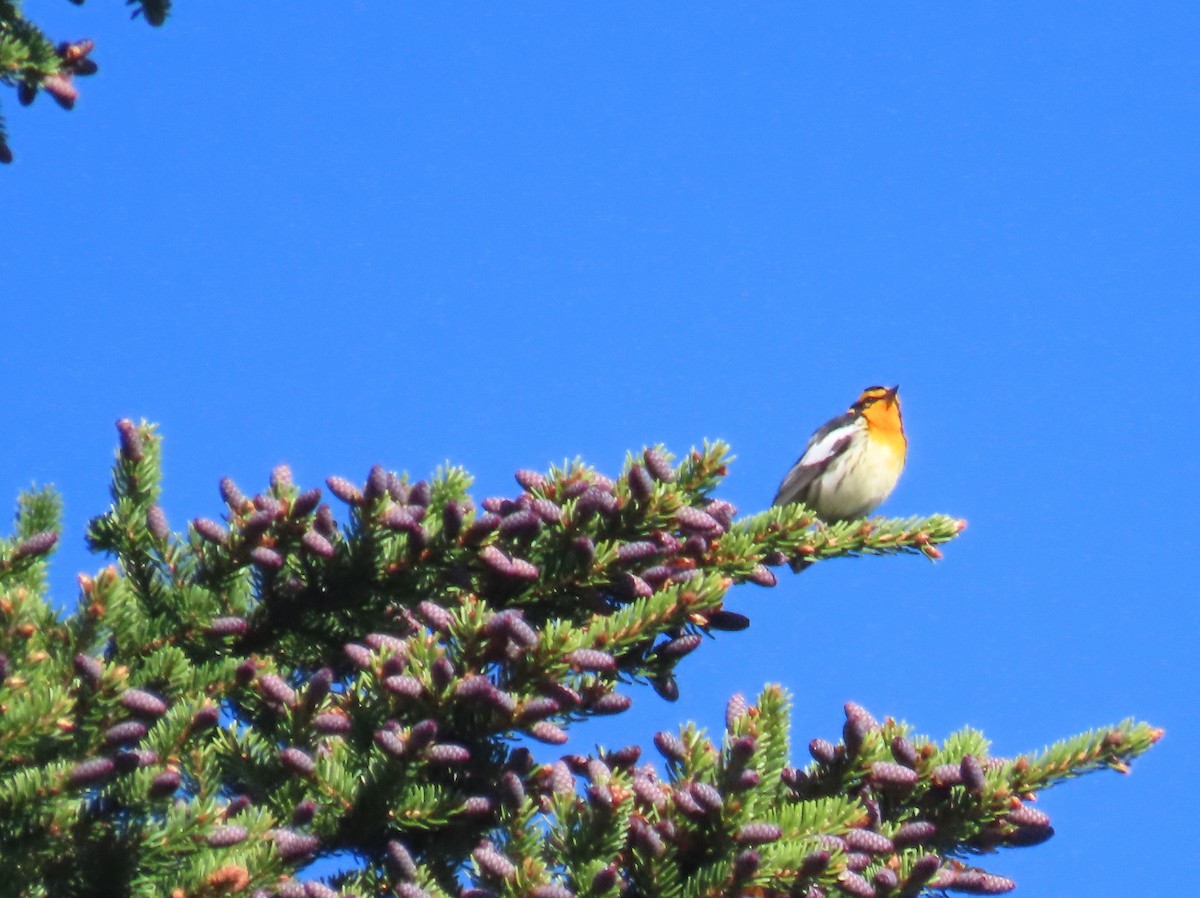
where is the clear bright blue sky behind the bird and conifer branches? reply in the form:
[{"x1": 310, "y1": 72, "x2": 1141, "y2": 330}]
[{"x1": 0, "y1": 0, "x2": 1200, "y2": 898}]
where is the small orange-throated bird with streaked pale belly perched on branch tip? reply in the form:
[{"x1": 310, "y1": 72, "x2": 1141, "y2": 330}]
[{"x1": 772, "y1": 387, "x2": 908, "y2": 568}]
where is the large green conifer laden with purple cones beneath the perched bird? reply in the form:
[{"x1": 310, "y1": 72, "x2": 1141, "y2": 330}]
[{"x1": 0, "y1": 420, "x2": 1160, "y2": 898}]
